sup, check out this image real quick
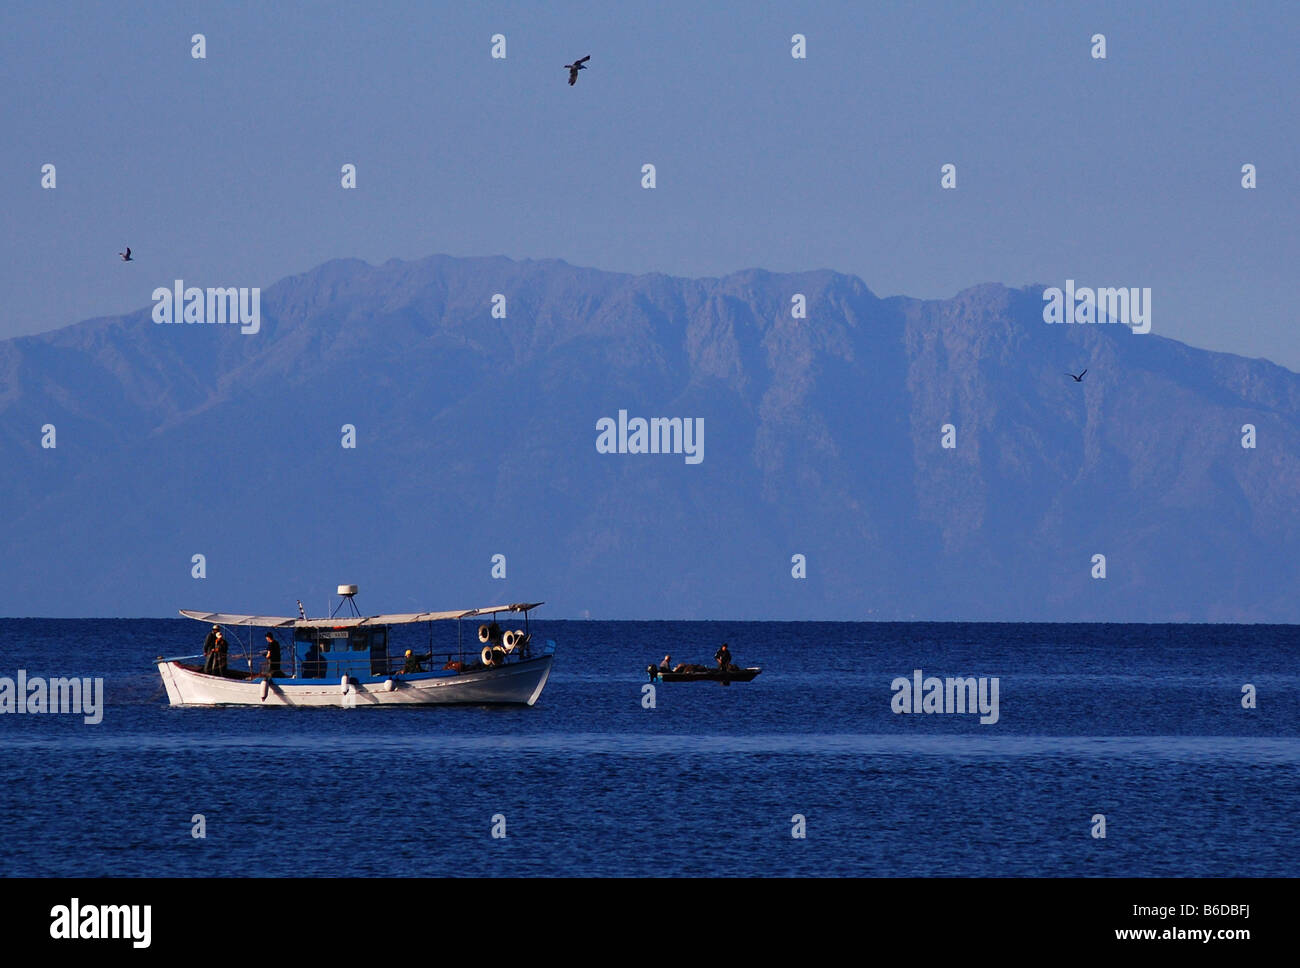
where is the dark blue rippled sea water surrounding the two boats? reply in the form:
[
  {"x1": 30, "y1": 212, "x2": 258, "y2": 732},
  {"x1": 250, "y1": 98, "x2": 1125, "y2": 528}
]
[{"x1": 0, "y1": 620, "x2": 1300, "y2": 876}]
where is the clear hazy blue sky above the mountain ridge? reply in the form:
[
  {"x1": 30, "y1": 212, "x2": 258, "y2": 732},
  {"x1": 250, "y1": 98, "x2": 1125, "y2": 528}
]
[{"x1": 0, "y1": 1, "x2": 1300, "y2": 370}]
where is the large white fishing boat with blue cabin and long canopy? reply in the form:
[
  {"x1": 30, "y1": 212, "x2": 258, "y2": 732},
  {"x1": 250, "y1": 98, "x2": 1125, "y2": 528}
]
[{"x1": 155, "y1": 585, "x2": 555, "y2": 707}]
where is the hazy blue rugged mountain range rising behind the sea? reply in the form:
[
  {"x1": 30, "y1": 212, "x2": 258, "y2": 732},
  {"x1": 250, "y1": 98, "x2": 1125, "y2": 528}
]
[{"x1": 0, "y1": 256, "x2": 1300, "y2": 618}]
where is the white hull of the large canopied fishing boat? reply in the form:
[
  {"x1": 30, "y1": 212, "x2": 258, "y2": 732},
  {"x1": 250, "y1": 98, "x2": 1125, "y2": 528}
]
[{"x1": 157, "y1": 655, "x2": 553, "y2": 708}]
